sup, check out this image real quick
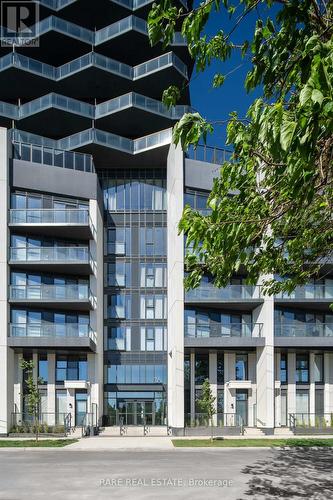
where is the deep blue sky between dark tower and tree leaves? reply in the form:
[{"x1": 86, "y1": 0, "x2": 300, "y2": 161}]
[{"x1": 190, "y1": 1, "x2": 273, "y2": 147}]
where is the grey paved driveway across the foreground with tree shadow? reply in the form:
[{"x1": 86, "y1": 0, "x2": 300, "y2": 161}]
[{"x1": 0, "y1": 449, "x2": 333, "y2": 500}]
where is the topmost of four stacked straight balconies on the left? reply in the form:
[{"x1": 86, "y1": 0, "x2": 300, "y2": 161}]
[{"x1": 9, "y1": 208, "x2": 96, "y2": 240}]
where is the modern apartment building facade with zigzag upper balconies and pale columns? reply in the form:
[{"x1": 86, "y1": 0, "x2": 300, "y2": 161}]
[{"x1": 0, "y1": 0, "x2": 333, "y2": 434}]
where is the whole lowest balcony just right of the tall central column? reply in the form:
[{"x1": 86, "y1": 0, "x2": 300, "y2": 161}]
[{"x1": 185, "y1": 323, "x2": 265, "y2": 347}]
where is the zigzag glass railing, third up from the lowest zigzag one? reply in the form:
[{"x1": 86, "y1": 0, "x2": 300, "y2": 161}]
[{"x1": 0, "y1": 52, "x2": 188, "y2": 81}]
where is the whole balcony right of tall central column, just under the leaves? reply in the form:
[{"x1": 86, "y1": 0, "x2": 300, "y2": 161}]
[{"x1": 185, "y1": 285, "x2": 263, "y2": 311}]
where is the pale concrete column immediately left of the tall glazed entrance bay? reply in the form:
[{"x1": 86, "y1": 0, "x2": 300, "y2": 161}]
[{"x1": 88, "y1": 197, "x2": 104, "y2": 424}]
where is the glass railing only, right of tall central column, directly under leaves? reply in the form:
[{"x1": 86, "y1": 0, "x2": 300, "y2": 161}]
[{"x1": 185, "y1": 285, "x2": 261, "y2": 302}]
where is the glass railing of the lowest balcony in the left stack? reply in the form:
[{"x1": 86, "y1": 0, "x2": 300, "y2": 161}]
[{"x1": 10, "y1": 323, "x2": 96, "y2": 342}]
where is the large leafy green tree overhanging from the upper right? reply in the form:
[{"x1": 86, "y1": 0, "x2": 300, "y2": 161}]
[{"x1": 149, "y1": 0, "x2": 333, "y2": 294}]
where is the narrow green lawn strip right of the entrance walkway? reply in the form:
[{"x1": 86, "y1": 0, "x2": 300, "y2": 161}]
[{"x1": 172, "y1": 438, "x2": 333, "y2": 448}]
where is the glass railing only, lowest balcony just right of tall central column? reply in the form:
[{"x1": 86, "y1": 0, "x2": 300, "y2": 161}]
[{"x1": 185, "y1": 323, "x2": 263, "y2": 338}]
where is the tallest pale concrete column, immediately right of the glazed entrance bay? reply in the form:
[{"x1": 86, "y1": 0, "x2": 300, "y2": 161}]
[{"x1": 167, "y1": 144, "x2": 184, "y2": 428}]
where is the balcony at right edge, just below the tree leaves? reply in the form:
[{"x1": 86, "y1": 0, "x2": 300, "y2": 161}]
[{"x1": 275, "y1": 283, "x2": 333, "y2": 310}]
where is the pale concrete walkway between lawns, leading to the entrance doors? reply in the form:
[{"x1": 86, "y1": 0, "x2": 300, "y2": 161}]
[{"x1": 65, "y1": 436, "x2": 174, "y2": 451}]
